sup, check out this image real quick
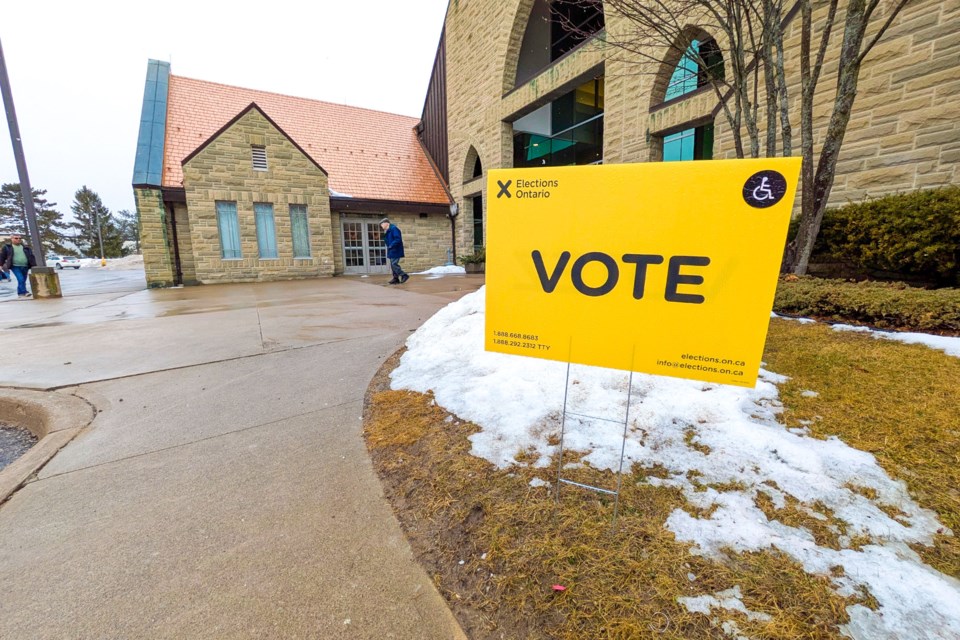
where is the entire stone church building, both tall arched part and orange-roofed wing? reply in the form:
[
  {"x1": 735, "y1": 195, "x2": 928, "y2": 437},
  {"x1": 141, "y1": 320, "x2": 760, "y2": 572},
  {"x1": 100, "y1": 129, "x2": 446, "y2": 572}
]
[{"x1": 134, "y1": 0, "x2": 960, "y2": 286}]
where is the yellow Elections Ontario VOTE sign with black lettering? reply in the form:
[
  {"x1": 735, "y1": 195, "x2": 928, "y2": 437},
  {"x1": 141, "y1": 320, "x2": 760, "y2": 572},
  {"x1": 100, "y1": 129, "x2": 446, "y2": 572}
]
[{"x1": 485, "y1": 158, "x2": 800, "y2": 387}]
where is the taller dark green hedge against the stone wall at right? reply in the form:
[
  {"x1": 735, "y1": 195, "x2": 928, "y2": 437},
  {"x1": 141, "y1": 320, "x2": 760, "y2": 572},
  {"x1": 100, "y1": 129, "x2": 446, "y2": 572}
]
[{"x1": 814, "y1": 186, "x2": 960, "y2": 286}]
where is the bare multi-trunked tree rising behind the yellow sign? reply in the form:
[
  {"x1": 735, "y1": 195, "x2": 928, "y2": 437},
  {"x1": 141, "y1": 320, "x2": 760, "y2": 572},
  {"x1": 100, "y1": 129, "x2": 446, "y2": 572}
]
[{"x1": 566, "y1": 0, "x2": 909, "y2": 274}]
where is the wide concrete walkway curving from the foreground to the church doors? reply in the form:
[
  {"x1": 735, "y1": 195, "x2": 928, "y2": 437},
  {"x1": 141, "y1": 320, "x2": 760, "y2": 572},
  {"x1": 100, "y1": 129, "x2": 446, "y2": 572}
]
[{"x1": 0, "y1": 276, "x2": 483, "y2": 639}]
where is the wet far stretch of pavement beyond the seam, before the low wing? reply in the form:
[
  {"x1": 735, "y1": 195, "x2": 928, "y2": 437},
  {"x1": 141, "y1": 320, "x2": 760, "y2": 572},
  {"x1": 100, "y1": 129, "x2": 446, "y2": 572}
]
[{"x1": 0, "y1": 269, "x2": 483, "y2": 389}]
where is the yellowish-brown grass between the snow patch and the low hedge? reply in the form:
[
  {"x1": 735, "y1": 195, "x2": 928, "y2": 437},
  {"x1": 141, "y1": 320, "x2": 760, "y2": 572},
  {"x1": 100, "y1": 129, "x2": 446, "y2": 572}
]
[{"x1": 764, "y1": 321, "x2": 960, "y2": 577}]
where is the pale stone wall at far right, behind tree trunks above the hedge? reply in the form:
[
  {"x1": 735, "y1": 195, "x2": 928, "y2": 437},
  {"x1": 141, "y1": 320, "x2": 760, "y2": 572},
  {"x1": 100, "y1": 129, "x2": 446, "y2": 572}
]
[{"x1": 700, "y1": 0, "x2": 960, "y2": 205}]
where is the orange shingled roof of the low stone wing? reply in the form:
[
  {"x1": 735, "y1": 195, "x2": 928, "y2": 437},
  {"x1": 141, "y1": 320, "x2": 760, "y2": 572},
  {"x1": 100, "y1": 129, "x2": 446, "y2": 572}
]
[{"x1": 163, "y1": 75, "x2": 449, "y2": 204}]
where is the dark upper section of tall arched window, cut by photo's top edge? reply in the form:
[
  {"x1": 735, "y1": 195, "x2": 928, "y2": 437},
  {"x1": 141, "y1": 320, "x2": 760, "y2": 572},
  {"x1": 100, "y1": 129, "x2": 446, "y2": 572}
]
[{"x1": 514, "y1": 0, "x2": 604, "y2": 87}]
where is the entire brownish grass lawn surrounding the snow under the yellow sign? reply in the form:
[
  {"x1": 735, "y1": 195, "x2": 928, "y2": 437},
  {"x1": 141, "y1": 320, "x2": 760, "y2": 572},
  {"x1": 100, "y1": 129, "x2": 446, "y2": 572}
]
[{"x1": 365, "y1": 320, "x2": 960, "y2": 640}]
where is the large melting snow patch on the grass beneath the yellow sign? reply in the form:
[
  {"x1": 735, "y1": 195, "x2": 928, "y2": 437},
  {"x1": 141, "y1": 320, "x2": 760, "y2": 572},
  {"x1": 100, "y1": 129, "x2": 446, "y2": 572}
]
[{"x1": 391, "y1": 288, "x2": 960, "y2": 640}]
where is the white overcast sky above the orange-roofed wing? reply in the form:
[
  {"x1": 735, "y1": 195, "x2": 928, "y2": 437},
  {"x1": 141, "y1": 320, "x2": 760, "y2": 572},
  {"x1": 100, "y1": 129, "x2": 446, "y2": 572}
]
[{"x1": 0, "y1": 0, "x2": 448, "y2": 217}]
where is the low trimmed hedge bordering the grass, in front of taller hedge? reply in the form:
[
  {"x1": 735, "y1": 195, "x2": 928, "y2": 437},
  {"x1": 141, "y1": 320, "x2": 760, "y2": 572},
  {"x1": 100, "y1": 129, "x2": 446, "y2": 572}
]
[{"x1": 773, "y1": 276, "x2": 960, "y2": 335}]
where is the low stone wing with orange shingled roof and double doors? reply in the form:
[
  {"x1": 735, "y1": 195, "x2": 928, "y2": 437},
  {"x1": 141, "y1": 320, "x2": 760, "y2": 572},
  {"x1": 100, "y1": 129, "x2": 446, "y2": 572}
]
[{"x1": 133, "y1": 60, "x2": 452, "y2": 287}]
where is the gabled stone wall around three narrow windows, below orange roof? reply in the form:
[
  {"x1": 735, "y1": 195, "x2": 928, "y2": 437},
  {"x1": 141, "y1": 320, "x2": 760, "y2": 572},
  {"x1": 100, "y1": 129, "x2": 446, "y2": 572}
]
[{"x1": 177, "y1": 109, "x2": 334, "y2": 283}]
